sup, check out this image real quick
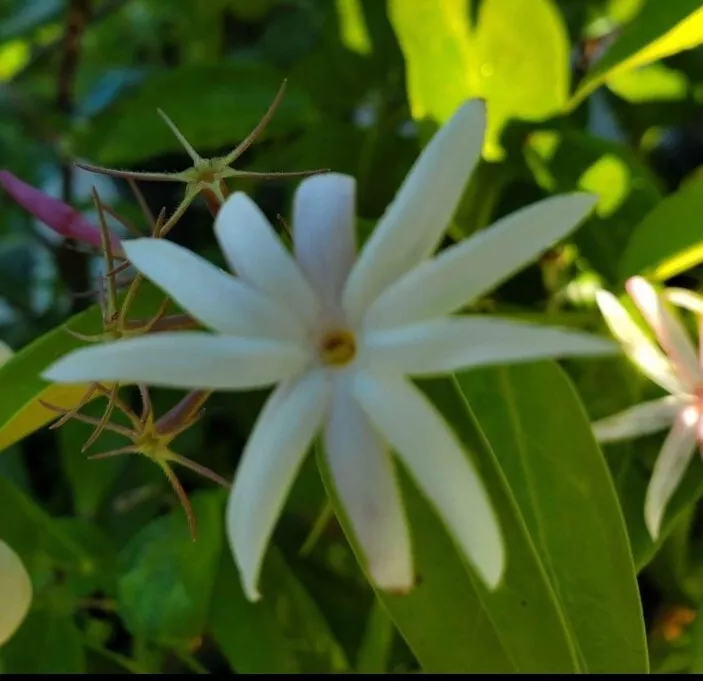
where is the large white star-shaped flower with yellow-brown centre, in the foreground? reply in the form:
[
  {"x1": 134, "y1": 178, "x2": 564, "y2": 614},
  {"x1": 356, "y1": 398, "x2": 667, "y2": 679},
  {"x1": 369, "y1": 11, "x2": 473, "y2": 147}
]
[{"x1": 45, "y1": 102, "x2": 617, "y2": 599}]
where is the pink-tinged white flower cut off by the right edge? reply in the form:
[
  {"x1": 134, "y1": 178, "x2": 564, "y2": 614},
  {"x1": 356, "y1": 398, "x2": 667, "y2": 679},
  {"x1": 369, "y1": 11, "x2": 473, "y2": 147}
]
[{"x1": 593, "y1": 277, "x2": 703, "y2": 539}]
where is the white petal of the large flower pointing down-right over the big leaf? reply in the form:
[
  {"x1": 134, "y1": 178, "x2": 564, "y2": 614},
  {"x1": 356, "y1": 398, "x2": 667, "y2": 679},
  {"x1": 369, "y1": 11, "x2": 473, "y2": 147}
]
[{"x1": 353, "y1": 372, "x2": 505, "y2": 588}]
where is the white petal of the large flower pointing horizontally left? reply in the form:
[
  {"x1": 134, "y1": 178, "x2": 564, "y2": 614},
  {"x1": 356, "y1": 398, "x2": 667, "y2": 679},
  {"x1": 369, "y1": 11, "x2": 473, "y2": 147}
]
[{"x1": 42, "y1": 331, "x2": 308, "y2": 390}]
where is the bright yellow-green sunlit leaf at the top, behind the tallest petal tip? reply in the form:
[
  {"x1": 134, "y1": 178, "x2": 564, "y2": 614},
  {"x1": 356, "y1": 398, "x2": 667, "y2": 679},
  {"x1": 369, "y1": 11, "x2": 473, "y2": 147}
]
[{"x1": 389, "y1": 0, "x2": 570, "y2": 160}]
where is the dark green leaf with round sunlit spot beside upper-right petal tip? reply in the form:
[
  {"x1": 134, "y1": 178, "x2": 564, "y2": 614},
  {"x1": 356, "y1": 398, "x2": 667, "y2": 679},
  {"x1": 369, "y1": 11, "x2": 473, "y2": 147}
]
[{"x1": 525, "y1": 129, "x2": 661, "y2": 285}]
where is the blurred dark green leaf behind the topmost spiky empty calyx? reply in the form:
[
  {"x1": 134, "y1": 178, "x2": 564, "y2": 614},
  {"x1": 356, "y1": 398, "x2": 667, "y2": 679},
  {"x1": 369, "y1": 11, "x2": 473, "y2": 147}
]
[{"x1": 74, "y1": 64, "x2": 314, "y2": 166}]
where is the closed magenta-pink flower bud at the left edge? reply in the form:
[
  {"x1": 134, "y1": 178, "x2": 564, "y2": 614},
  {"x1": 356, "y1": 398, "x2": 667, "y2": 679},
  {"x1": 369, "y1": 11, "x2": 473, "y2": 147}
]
[{"x1": 0, "y1": 170, "x2": 122, "y2": 253}]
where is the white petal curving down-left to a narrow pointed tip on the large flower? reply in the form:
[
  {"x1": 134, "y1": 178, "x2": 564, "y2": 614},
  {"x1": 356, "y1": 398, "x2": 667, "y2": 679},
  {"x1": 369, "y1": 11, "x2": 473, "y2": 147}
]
[{"x1": 226, "y1": 371, "x2": 330, "y2": 601}]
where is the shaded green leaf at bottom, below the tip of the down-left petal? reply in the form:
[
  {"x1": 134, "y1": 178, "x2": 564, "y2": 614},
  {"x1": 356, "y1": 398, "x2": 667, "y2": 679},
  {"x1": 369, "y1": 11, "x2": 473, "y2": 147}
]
[{"x1": 210, "y1": 545, "x2": 349, "y2": 674}]
